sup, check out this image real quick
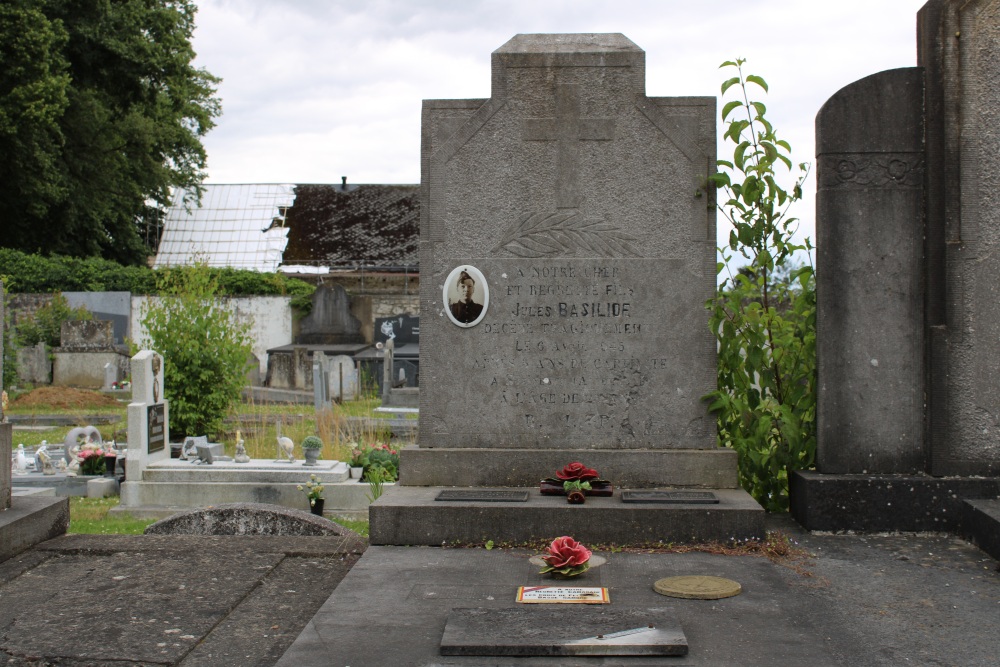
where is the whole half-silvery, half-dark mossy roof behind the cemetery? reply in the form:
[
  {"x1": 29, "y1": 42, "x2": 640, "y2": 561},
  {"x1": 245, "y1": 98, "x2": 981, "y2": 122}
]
[{"x1": 154, "y1": 182, "x2": 420, "y2": 272}]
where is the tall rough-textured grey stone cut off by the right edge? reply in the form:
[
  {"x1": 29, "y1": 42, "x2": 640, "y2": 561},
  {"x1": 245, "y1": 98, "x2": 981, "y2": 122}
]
[{"x1": 918, "y1": 0, "x2": 1000, "y2": 475}]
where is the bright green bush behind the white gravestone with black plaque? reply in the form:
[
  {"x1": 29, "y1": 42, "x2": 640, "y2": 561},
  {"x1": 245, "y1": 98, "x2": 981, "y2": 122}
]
[{"x1": 140, "y1": 264, "x2": 251, "y2": 437}]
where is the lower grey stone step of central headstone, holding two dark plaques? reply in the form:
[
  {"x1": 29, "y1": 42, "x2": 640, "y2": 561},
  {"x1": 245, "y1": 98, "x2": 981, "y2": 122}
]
[{"x1": 368, "y1": 486, "x2": 766, "y2": 546}]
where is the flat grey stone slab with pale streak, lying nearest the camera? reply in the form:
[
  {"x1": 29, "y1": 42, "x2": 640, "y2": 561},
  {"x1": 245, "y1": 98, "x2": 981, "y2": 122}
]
[{"x1": 441, "y1": 607, "x2": 688, "y2": 657}]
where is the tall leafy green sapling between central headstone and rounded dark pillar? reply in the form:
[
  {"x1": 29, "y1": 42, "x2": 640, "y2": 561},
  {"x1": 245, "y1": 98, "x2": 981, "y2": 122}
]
[{"x1": 708, "y1": 60, "x2": 816, "y2": 511}]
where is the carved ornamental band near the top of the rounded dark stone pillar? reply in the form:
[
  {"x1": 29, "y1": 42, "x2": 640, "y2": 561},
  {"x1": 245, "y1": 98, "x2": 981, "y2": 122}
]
[{"x1": 818, "y1": 153, "x2": 924, "y2": 188}]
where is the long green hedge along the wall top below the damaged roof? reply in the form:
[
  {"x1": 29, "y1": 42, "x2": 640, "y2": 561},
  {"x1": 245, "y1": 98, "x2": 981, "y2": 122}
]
[{"x1": 0, "y1": 248, "x2": 316, "y2": 298}]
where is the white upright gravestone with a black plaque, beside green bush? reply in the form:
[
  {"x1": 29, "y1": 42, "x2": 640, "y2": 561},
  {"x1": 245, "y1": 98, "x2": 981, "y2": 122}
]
[{"x1": 122, "y1": 350, "x2": 170, "y2": 486}]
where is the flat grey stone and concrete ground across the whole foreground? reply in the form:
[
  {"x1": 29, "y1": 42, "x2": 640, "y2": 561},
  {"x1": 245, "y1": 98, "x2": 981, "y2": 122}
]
[{"x1": 0, "y1": 515, "x2": 1000, "y2": 667}]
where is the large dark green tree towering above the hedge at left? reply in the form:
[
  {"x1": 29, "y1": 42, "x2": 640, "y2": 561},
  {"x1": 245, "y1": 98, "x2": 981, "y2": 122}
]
[{"x1": 0, "y1": 0, "x2": 220, "y2": 264}]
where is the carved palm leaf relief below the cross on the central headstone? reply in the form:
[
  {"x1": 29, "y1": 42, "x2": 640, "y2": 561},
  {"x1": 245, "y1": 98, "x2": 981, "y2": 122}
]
[{"x1": 493, "y1": 211, "x2": 641, "y2": 259}]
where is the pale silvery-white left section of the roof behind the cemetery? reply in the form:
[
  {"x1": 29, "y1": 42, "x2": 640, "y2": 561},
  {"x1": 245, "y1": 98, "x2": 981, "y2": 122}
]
[{"x1": 153, "y1": 183, "x2": 295, "y2": 272}]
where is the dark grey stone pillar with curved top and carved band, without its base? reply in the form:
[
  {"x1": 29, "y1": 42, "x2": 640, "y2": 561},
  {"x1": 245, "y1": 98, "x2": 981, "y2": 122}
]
[{"x1": 816, "y1": 67, "x2": 925, "y2": 473}]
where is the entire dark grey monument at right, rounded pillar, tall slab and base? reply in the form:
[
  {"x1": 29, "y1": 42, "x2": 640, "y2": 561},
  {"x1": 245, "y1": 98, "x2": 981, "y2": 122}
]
[{"x1": 790, "y1": 0, "x2": 1000, "y2": 531}]
